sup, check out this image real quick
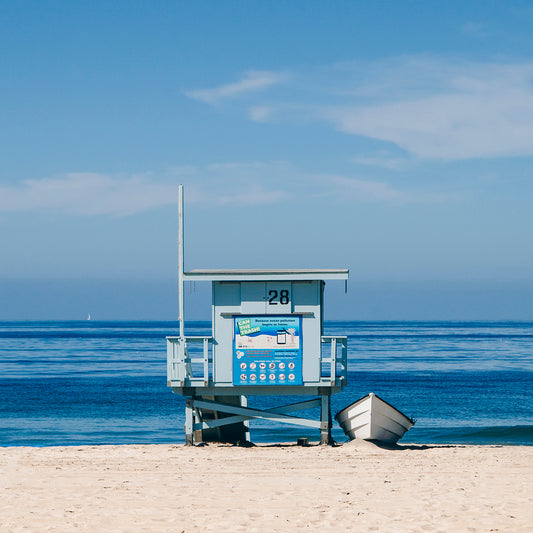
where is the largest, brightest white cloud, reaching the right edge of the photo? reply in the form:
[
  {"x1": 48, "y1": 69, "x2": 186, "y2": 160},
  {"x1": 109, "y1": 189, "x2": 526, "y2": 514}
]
[{"x1": 323, "y1": 84, "x2": 533, "y2": 160}]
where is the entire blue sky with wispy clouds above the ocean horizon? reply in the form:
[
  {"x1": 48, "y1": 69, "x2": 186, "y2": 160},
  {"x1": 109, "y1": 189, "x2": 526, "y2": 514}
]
[{"x1": 0, "y1": 1, "x2": 533, "y2": 319}]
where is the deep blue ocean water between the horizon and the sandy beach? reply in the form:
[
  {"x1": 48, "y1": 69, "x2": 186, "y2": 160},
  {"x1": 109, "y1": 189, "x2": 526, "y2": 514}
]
[{"x1": 0, "y1": 321, "x2": 533, "y2": 446}]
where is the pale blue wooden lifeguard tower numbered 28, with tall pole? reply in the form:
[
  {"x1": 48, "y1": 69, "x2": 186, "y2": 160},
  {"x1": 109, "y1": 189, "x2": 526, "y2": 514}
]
[{"x1": 167, "y1": 185, "x2": 348, "y2": 445}]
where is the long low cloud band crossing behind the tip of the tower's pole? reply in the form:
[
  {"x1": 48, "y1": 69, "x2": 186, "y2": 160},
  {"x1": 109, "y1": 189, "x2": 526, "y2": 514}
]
[{"x1": 0, "y1": 161, "x2": 443, "y2": 217}]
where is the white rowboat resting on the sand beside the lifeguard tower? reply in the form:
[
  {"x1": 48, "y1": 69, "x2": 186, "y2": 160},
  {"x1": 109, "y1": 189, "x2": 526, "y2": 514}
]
[{"x1": 335, "y1": 392, "x2": 415, "y2": 444}]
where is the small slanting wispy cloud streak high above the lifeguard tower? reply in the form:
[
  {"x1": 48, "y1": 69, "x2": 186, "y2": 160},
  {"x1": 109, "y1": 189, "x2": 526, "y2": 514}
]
[{"x1": 185, "y1": 70, "x2": 287, "y2": 104}]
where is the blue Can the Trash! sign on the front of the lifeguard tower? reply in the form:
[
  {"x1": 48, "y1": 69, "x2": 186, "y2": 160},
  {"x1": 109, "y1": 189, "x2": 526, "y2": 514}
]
[{"x1": 233, "y1": 315, "x2": 303, "y2": 385}]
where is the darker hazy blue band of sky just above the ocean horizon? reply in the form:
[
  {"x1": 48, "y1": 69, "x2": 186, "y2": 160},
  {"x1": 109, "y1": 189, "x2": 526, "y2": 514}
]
[{"x1": 0, "y1": 280, "x2": 533, "y2": 321}]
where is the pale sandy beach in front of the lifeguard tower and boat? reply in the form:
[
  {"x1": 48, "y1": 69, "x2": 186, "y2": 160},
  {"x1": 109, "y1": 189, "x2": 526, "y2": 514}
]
[{"x1": 0, "y1": 441, "x2": 533, "y2": 532}]
